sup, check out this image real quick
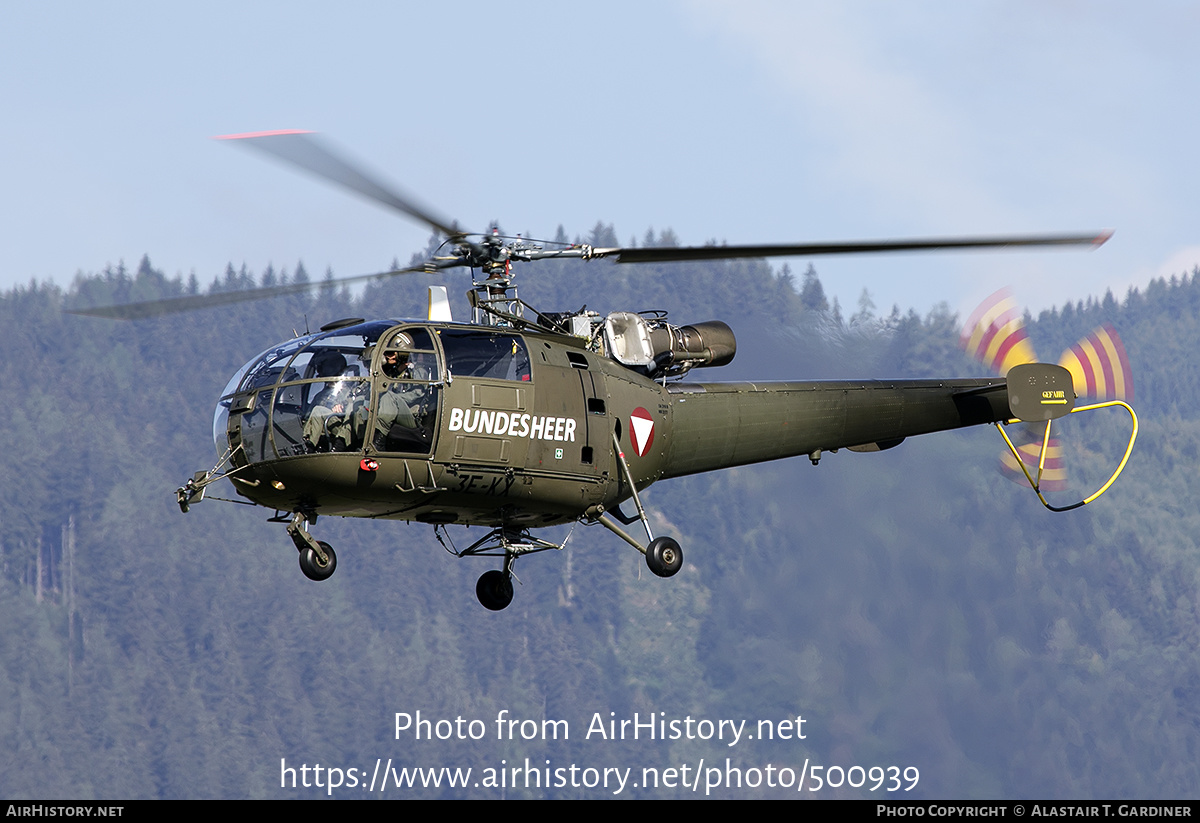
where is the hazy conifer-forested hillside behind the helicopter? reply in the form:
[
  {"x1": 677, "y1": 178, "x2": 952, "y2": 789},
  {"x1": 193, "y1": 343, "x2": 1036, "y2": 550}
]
[{"x1": 0, "y1": 235, "x2": 1200, "y2": 799}]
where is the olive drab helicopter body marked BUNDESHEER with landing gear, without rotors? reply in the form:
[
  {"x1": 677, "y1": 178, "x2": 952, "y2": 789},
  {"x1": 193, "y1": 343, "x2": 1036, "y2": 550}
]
[{"x1": 178, "y1": 304, "x2": 1089, "y2": 608}]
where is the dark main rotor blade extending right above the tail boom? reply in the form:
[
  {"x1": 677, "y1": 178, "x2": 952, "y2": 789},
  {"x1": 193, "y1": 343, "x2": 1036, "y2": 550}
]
[{"x1": 592, "y1": 232, "x2": 1112, "y2": 263}]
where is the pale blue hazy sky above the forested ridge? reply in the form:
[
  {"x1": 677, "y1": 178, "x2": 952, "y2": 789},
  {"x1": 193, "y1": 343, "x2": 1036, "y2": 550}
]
[{"x1": 0, "y1": 0, "x2": 1200, "y2": 320}]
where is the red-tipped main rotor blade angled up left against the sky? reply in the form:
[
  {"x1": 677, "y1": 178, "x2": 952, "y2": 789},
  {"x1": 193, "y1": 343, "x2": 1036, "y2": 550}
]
[{"x1": 215, "y1": 131, "x2": 463, "y2": 238}]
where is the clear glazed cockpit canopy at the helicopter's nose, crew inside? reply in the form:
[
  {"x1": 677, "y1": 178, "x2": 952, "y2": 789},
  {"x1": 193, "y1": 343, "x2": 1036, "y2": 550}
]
[{"x1": 212, "y1": 320, "x2": 530, "y2": 465}]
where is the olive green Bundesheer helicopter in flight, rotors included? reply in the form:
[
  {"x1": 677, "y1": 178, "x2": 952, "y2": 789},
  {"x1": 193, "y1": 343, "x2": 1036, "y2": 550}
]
[{"x1": 74, "y1": 131, "x2": 1136, "y2": 611}]
